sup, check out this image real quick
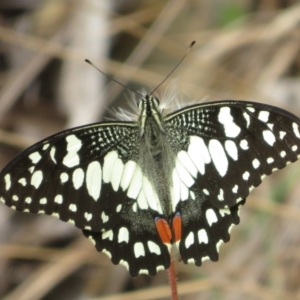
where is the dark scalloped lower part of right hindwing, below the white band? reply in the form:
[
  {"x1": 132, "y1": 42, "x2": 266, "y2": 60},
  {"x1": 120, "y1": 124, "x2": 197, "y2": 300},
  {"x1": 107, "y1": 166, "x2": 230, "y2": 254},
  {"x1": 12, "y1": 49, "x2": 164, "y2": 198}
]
[{"x1": 177, "y1": 188, "x2": 245, "y2": 266}]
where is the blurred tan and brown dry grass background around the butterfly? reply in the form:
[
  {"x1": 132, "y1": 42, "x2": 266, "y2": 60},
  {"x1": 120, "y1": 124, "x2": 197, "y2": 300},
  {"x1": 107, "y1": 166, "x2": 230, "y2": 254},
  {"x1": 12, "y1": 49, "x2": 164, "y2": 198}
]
[{"x1": 0, "y1": 0, "x2": 300, "y2": 300}]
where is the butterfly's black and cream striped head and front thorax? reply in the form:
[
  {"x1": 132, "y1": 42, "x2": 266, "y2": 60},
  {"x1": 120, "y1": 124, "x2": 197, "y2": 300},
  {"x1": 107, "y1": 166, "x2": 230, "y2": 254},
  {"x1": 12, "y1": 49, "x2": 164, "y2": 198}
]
[{"x1": 138, "y1": 95, "x2": 165, "y2": 137}]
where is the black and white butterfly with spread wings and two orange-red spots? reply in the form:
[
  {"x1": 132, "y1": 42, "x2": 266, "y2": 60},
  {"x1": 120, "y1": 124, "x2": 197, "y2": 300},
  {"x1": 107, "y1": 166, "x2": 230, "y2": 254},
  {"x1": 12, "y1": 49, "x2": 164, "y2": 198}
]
[{"x1": 0, "y1": 95, "x2": 300, "y2": 276}]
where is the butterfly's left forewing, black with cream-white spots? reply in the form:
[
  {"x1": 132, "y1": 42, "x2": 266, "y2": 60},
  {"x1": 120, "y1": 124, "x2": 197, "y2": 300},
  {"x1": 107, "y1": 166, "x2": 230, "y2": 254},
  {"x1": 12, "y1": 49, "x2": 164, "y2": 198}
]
[{"x1": 0, "y1": 123, "x2": 137, "y2": 231}]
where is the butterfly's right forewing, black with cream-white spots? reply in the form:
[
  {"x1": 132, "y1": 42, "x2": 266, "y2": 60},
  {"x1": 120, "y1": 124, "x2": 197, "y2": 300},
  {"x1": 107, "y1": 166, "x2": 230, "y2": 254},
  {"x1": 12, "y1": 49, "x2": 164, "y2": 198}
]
[{"x1": 166, "y1": 101, "x2": 300, "y2": 208}]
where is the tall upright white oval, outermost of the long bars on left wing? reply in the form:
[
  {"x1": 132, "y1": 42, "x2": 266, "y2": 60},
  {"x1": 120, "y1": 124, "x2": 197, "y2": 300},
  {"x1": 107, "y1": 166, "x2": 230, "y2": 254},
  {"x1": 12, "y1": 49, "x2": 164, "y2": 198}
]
[{"x1": 85, "y1": 161, "x2": 102, "y2": 201}]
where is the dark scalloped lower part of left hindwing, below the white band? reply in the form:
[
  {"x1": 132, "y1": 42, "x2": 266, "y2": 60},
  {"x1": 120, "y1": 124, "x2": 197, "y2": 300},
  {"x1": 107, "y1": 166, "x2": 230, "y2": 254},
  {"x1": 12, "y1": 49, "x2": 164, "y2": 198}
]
[{"x1": 83, "y1": 201, "x2": 170, "y2": 277}]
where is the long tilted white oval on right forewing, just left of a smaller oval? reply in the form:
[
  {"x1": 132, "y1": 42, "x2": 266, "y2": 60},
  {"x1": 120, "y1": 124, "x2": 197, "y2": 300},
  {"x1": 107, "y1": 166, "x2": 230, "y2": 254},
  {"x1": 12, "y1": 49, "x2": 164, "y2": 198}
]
[{"x1": 208, "y1": 139, "x2": 228, "y2": 177}]
